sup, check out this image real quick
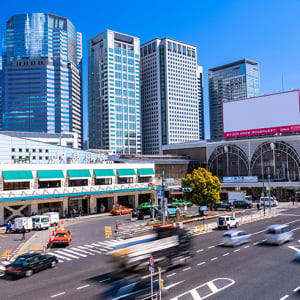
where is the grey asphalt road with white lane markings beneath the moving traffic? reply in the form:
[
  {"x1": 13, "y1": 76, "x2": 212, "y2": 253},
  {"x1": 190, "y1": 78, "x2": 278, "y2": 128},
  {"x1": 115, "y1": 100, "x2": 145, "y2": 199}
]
[{"x1": 0, "y1": 208, "x2": 300, "y2": 300}]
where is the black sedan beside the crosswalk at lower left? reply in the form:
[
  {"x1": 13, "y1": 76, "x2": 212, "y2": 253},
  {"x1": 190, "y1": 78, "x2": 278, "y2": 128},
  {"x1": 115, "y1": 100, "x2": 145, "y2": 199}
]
[{"x1": 5, "y1": 253, "x2": 58, "y2": 277}]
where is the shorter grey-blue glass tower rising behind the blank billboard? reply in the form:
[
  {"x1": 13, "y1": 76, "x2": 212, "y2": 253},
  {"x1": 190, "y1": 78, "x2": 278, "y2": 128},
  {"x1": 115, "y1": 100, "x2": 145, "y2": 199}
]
[{"x1": 208, "y1": 59, "x2": 260, "y2": 139}]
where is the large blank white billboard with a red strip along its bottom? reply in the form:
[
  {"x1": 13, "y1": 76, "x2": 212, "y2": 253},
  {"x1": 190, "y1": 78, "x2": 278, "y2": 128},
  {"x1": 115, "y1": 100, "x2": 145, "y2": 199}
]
[{"x1": 223, "y1": 90, "x2": 300, "y2": 138}]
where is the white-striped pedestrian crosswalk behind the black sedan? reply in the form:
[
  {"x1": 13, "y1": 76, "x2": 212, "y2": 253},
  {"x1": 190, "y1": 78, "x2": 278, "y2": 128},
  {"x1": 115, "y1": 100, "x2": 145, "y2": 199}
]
[{"x1": 0, "y1": 239, "x2": 122, "y2": 273}]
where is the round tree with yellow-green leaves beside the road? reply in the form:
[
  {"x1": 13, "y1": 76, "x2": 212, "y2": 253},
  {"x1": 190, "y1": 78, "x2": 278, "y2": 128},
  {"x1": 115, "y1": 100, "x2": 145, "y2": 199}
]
[{"x1": 181, "y1": 168, "x2": 221, "y2": 207}]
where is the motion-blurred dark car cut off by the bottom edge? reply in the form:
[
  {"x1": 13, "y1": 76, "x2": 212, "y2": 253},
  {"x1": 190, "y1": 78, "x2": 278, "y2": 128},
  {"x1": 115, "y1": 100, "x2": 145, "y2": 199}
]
[{"x1": 98, "y1": 280, "x2": 159, "y2": 300}]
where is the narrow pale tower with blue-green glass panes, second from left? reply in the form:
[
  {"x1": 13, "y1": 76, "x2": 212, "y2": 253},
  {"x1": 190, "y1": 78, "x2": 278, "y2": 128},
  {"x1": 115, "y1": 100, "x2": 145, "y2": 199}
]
[{"x1": 88, "y1": 30, "x2": 141, "y2": 154}]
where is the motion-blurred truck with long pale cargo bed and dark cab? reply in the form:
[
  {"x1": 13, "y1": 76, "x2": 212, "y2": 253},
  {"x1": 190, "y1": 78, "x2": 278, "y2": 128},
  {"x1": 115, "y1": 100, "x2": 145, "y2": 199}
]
[{"x1": 107, "y1": 227, "x2": 192, "y2": 271}]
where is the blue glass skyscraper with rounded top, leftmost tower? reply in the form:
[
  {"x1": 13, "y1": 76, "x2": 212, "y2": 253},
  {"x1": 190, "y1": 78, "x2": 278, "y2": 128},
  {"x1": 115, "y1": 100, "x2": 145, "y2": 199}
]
[{"x1": 2, "y1": 13, "x2": 82, "y2": 147}]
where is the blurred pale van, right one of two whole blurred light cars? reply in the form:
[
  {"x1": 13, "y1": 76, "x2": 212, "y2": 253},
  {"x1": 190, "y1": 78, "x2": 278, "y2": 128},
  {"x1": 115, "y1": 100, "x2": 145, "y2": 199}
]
[{"x1": 265, "y1": 224, "x2": 293, "y2": 245}]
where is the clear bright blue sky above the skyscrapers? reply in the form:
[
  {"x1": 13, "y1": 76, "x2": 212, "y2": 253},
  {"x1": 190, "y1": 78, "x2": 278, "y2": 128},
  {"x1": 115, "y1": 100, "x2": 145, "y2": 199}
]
[{"x1": 0, "y1": 0, "x2": 300, "y2": 137}]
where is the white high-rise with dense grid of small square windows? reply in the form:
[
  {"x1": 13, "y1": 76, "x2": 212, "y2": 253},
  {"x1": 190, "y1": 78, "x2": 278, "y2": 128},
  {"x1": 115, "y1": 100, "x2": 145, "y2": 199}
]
[{"x1": 141, "y1": 38, "x2": 204, "y2": 154}]
